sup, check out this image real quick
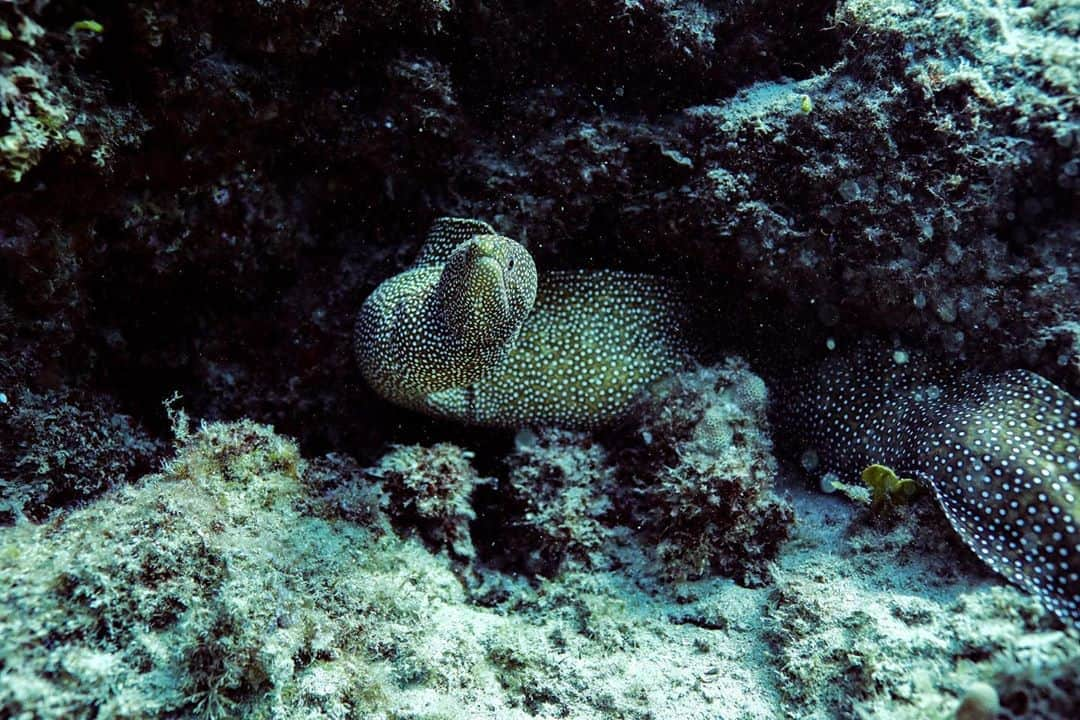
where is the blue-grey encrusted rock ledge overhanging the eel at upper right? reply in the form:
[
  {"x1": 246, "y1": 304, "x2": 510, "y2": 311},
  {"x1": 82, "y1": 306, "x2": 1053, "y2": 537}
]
[{"x1": 459, "y1": 0, "x2": 1080, "y2": 392}]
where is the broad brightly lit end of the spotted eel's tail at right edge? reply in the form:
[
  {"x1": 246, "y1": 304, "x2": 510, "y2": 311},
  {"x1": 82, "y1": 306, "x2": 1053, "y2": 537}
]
[{"x1": 915, "y1": 370, "x2": 1080, "y2": 626}]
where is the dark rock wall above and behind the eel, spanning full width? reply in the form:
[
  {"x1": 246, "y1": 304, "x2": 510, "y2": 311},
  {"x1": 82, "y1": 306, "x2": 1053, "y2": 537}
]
[{"x1": 0, "y1": 0, "x2": 1080, "y2": 462}]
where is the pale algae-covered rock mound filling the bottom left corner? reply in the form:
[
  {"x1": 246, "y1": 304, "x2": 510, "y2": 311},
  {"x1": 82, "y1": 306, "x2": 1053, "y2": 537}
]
[{"x1": 0, "y1": 422, "x2": 406, "y2": 718}]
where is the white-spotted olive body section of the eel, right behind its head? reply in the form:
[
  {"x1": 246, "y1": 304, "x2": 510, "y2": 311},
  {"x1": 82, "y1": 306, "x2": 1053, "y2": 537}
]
[{"x1": 453, "y1": 271, "x2": 687, "y2": 429}]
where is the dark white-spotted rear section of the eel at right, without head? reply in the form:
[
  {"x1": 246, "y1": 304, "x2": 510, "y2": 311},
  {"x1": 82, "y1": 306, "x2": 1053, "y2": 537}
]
[{"x1": 775, "y1": 343, "x2": 1080, "y2": 627}]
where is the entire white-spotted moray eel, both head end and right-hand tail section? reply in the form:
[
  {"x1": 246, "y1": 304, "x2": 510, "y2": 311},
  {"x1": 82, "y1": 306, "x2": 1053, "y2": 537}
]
[{"x1": 356, "y1": 218, "x2": 1080, "y2": 626}]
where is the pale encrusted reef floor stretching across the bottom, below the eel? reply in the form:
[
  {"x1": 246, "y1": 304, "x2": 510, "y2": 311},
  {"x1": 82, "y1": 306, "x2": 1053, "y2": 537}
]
[{"x1": 0, "y1": 418, "x2": 1080, "y2": 720}]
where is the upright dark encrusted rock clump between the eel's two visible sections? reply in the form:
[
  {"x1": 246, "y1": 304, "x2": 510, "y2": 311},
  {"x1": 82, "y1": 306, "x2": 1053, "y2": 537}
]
[{"x1": 616, "y1": 357, "x2": 795, "y2": 586}]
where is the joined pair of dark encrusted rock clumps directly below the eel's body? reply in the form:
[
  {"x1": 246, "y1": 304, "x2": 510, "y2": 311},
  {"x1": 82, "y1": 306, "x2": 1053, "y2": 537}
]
[{"x1": 481, "y1": 358, "x2": 794, "y2": 585}]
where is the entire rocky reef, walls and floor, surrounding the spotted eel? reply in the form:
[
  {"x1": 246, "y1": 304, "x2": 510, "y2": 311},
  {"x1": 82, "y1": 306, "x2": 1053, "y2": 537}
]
[{"x1": 0, "y1": 0, "x2": 1080, "y2": 720}]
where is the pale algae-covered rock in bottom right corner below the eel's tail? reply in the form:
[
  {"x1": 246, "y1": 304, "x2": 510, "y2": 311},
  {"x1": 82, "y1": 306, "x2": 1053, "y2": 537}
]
[{"x1": 764, "y1": 548, "x2": 1080, "y2": 720}]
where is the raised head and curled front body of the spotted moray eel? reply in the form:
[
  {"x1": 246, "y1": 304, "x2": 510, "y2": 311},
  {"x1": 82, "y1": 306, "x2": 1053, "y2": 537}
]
[{"x1": 355, "y1": 218, "x2": 688, "y2": 429}]
